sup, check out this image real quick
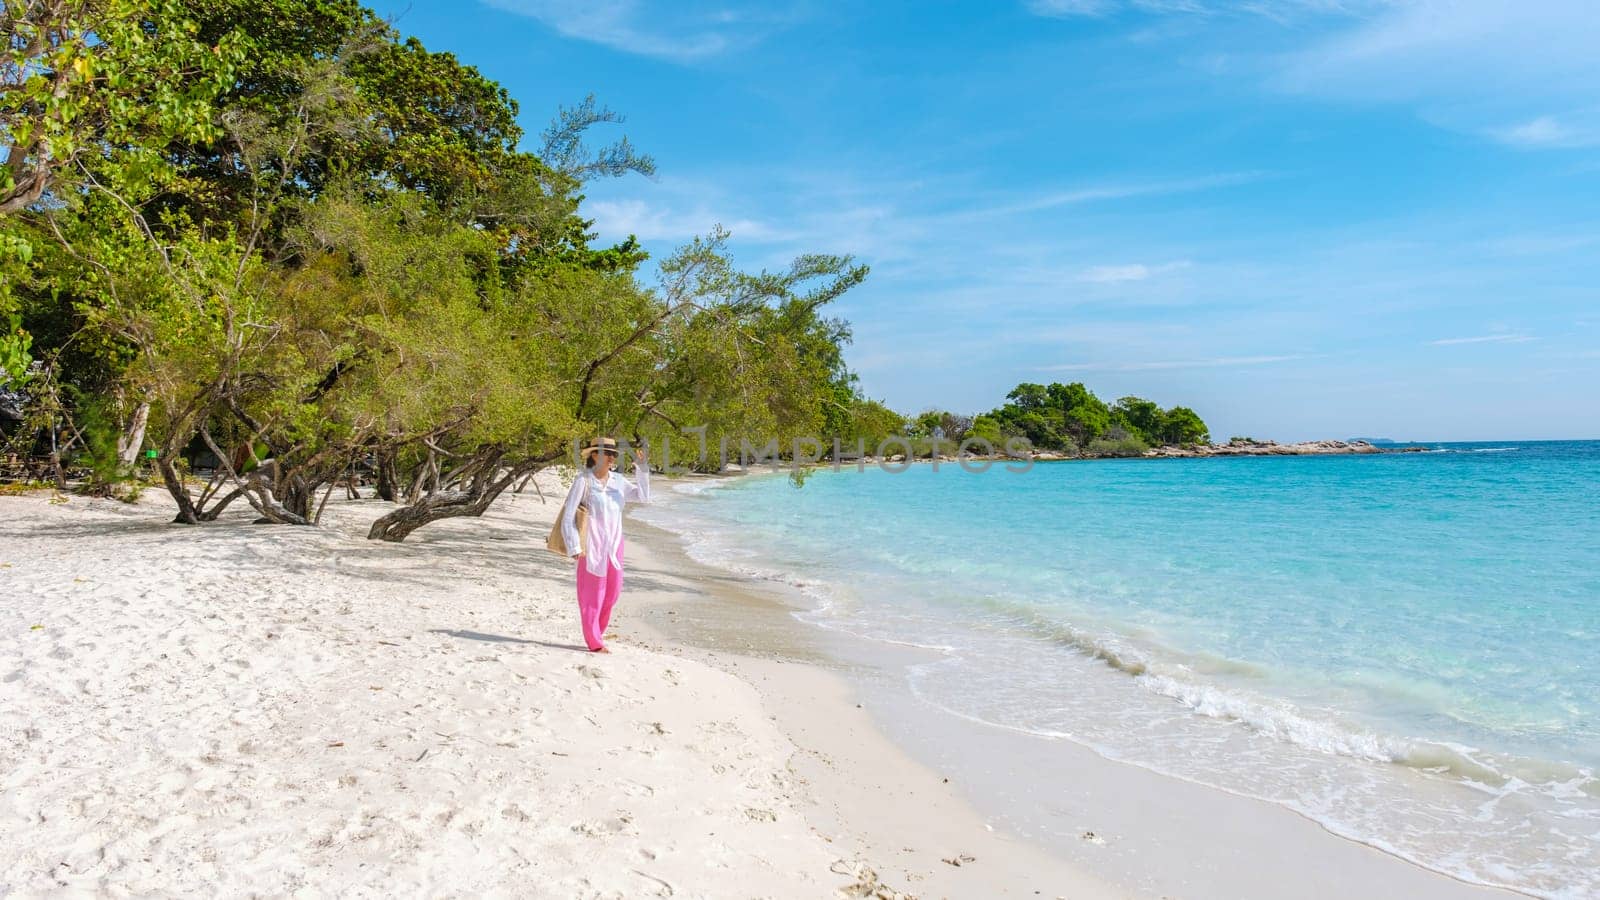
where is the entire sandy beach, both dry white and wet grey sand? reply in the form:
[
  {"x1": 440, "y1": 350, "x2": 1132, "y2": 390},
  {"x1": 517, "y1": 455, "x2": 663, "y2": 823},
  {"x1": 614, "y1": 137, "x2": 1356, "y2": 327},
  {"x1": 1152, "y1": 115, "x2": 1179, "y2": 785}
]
[{"x1": 0, "y1": 477, "x2": 1536, "y2": 898}]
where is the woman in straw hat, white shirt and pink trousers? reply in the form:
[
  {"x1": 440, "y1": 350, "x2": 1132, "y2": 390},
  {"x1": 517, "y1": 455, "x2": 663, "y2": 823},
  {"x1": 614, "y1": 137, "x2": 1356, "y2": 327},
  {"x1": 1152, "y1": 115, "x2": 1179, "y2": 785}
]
[{"x1": 562, "y1": 437, "x2": 650, "y2": 653}]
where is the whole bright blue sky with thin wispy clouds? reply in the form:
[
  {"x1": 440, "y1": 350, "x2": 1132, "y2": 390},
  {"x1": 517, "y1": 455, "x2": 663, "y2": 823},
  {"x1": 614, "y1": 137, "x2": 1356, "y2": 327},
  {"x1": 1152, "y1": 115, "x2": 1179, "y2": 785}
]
[{"x1": 376, "y1": 0, "x2": 1600, "y2": 440}]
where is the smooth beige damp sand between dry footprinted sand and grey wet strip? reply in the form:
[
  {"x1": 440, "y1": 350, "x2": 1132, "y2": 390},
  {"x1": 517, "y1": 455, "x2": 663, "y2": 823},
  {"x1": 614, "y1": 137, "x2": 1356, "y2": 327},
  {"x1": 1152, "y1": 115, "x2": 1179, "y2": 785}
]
[{"x1": 611, "y1": 519, "x2": 1141, "y2": 898}]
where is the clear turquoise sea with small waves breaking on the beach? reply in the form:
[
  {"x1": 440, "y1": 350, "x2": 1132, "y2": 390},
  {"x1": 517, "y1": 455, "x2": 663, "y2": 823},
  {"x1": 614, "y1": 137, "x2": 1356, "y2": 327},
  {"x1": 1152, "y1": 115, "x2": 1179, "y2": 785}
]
[{"x1": 643, "y1": 442, "x2": 1600, "y2": 897}]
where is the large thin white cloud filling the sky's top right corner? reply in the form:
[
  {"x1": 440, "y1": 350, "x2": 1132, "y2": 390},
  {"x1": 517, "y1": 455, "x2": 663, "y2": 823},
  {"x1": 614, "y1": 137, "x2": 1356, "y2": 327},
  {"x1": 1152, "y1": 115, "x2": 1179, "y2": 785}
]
[{"x1": 1026, "y1": 0, "x2": 1600, "y2": 149}]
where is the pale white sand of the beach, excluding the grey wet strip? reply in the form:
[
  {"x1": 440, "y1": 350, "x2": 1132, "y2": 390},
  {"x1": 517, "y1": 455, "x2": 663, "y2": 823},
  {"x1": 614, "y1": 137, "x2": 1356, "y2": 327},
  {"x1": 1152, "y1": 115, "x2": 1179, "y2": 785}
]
[{"x1": 0, "y1": 482, "x2": 1109, "y2": 897}]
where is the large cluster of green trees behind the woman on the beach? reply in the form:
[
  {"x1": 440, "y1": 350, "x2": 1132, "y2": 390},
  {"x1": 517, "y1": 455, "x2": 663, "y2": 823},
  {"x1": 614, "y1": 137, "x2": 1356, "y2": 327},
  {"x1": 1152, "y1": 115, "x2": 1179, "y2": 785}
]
[{"x1": 0, "y1": 0, "x2": 876, "y2": 528}]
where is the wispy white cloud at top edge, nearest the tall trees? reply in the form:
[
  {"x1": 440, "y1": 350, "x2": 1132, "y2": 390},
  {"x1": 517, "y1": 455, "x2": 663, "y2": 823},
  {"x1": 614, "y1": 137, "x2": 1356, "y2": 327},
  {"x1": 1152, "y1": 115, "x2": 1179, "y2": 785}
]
[{"x1": 483, "y1": 0, "x2": 795, "y2": 62}]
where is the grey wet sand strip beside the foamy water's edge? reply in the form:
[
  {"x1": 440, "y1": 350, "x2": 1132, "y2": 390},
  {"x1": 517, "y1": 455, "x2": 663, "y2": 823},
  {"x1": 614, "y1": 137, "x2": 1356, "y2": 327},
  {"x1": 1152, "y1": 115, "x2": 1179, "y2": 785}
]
[{"x1": 630, "y1": 471, "x2": 1523, "y2": 898}]
